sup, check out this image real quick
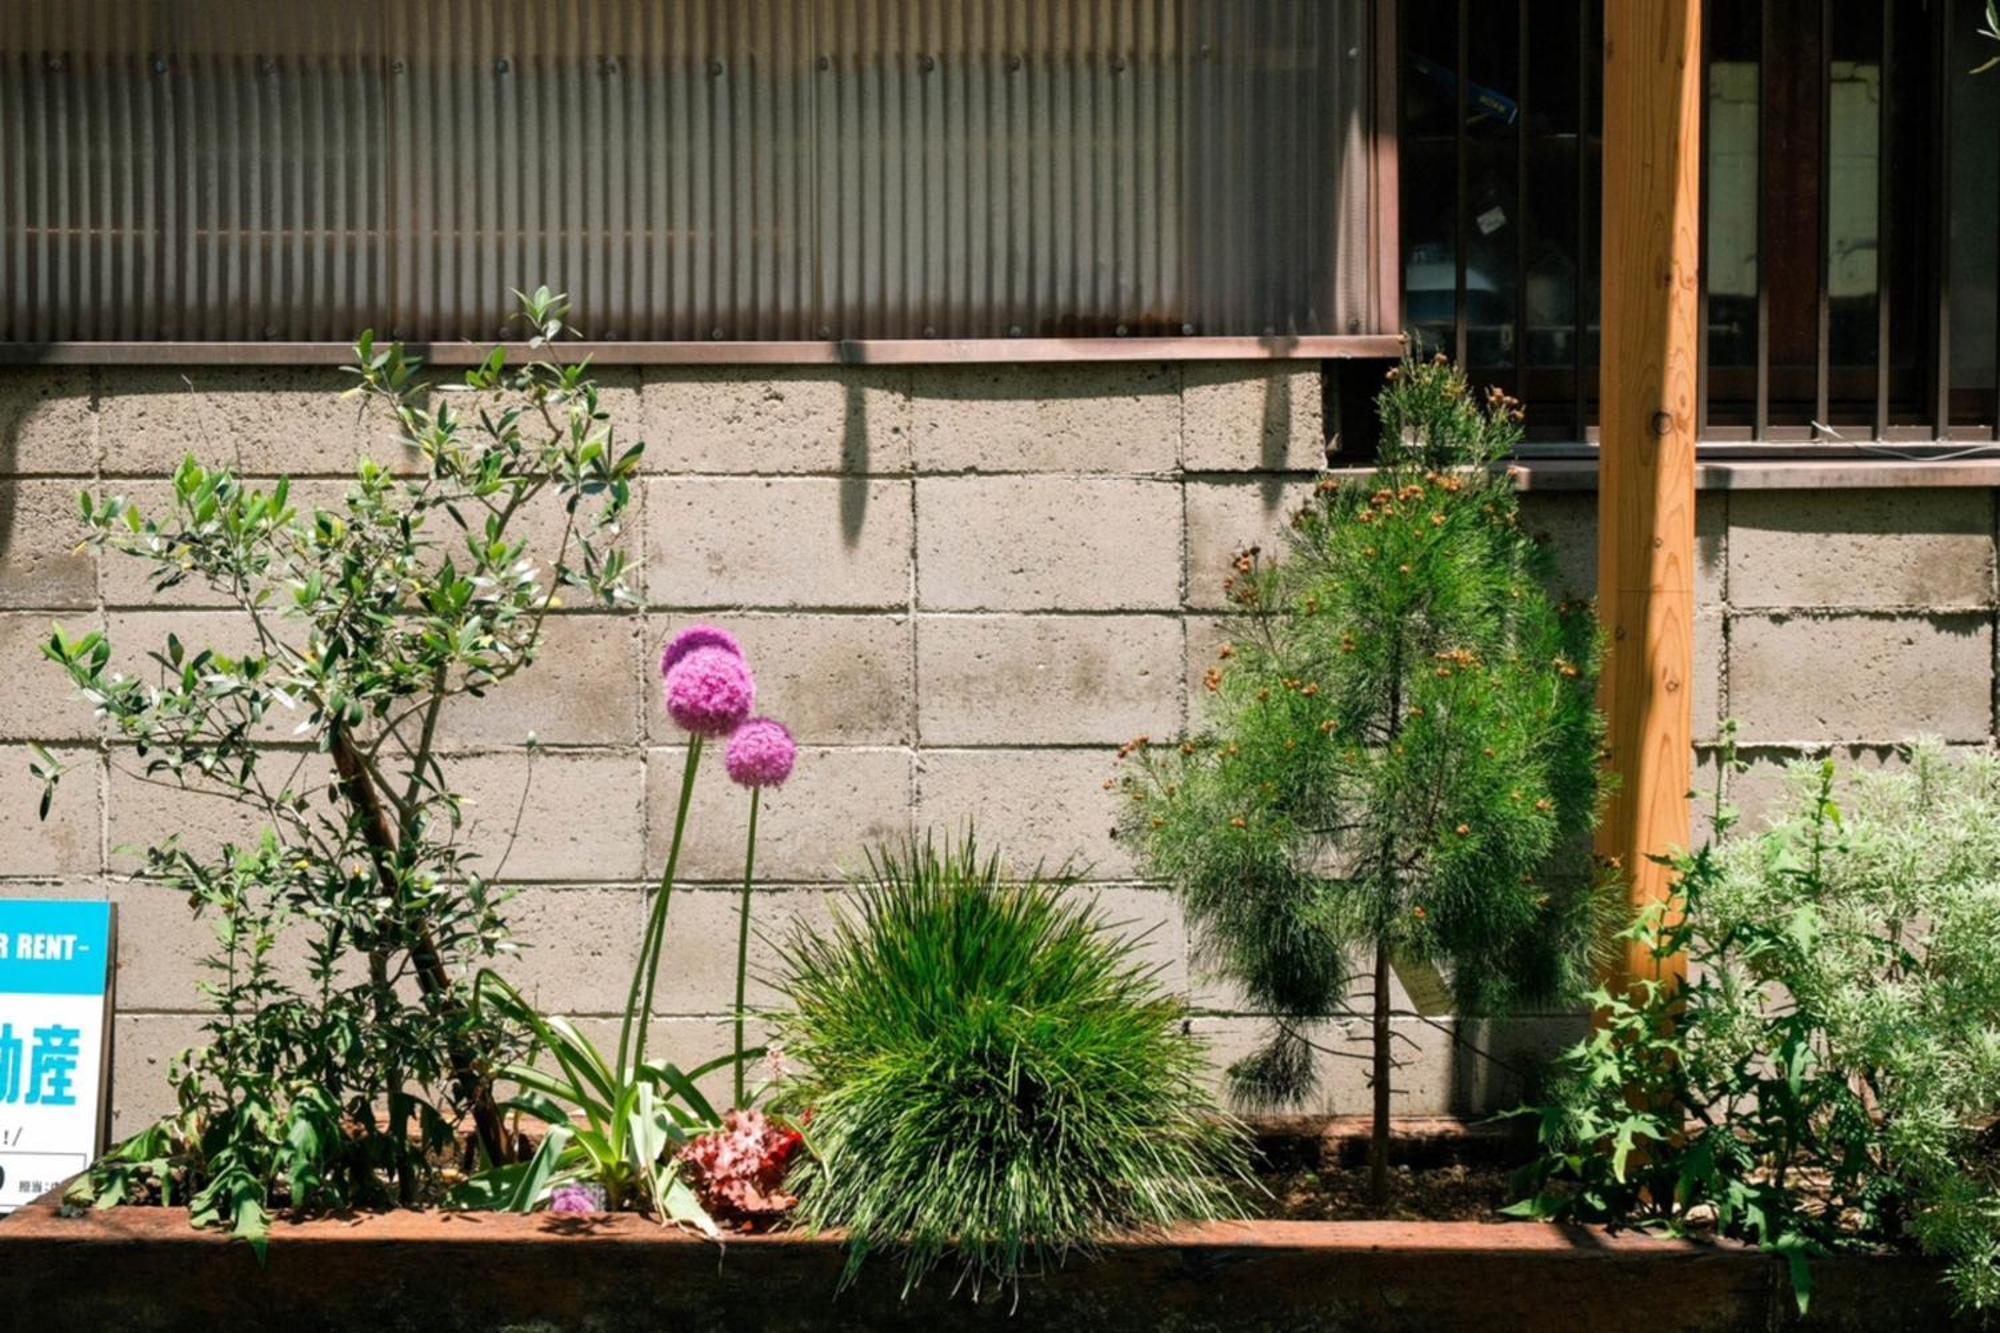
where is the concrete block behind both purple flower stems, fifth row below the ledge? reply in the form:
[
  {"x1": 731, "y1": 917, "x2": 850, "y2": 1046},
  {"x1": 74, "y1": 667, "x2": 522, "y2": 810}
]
[{"x1": 644, "y1": 885, "x2": 842, "y2": 1017}]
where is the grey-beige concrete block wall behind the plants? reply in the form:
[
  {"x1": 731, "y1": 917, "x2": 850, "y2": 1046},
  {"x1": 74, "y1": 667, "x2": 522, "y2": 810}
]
[{"x1": 0, "y1": 362, "x2": 1996, "y2": 1129}]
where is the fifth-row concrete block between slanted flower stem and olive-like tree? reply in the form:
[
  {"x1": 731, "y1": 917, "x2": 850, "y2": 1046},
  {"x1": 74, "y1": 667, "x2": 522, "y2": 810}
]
[{"x1": 494, "y1": 885, "x2": 648, "y2": 1013}]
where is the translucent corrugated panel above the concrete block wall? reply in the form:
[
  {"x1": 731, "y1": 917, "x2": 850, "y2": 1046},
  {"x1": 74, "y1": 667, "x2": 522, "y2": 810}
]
[{"x1": 0, "y1": 0, "x2": 1378, "y2": 342}]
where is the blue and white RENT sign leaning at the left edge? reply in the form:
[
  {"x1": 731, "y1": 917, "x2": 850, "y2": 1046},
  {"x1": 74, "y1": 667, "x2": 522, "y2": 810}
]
[{"x1": 0, "y1": 901, "x2": 116, "y2": 1213}]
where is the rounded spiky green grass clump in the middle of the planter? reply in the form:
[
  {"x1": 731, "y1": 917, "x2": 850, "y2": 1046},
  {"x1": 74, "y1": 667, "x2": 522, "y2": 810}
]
[{"x1": 778, "y1": 835, "x2": 1248, "y2": 1293}]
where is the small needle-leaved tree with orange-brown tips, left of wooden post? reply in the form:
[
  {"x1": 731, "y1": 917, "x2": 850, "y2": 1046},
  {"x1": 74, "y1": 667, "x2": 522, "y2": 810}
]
[{"x1": 1120, "y1": 358, "x2": 1602, "y2": 1207}]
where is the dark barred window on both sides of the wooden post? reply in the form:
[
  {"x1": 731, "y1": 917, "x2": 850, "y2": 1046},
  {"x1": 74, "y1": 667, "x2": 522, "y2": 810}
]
[{"x1": 1400, "y1": 0, "x2": 2000, "y2": 448}]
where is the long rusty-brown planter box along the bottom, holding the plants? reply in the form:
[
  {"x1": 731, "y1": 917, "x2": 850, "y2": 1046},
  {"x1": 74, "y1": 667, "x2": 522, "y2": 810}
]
[{"x1": 0, "y1": 1199, "x2": 1950, "y2": 1333}]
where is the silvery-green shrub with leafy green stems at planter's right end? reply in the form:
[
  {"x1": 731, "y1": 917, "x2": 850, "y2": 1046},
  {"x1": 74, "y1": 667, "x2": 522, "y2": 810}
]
[{"x1": 1518, "y1": 741, "x2": 2000, "y2": 1307}]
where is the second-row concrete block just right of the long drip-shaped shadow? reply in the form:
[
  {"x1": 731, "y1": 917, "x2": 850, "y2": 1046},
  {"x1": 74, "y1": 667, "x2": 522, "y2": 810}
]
[{"x1": 916, "y1": 476, "x2": 1180, "y2": 610}]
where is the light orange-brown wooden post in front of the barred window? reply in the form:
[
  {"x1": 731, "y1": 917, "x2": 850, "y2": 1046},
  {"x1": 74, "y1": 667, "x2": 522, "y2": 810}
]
[{"x1": 1598, "y1": 0, "x2": 1702, "y2": 983}]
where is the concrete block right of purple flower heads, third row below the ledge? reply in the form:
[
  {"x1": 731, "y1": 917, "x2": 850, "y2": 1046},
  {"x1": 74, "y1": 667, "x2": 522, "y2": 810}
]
[{"x1": 916, "y1": 616, "x2": 1182, "y2": 745}]
